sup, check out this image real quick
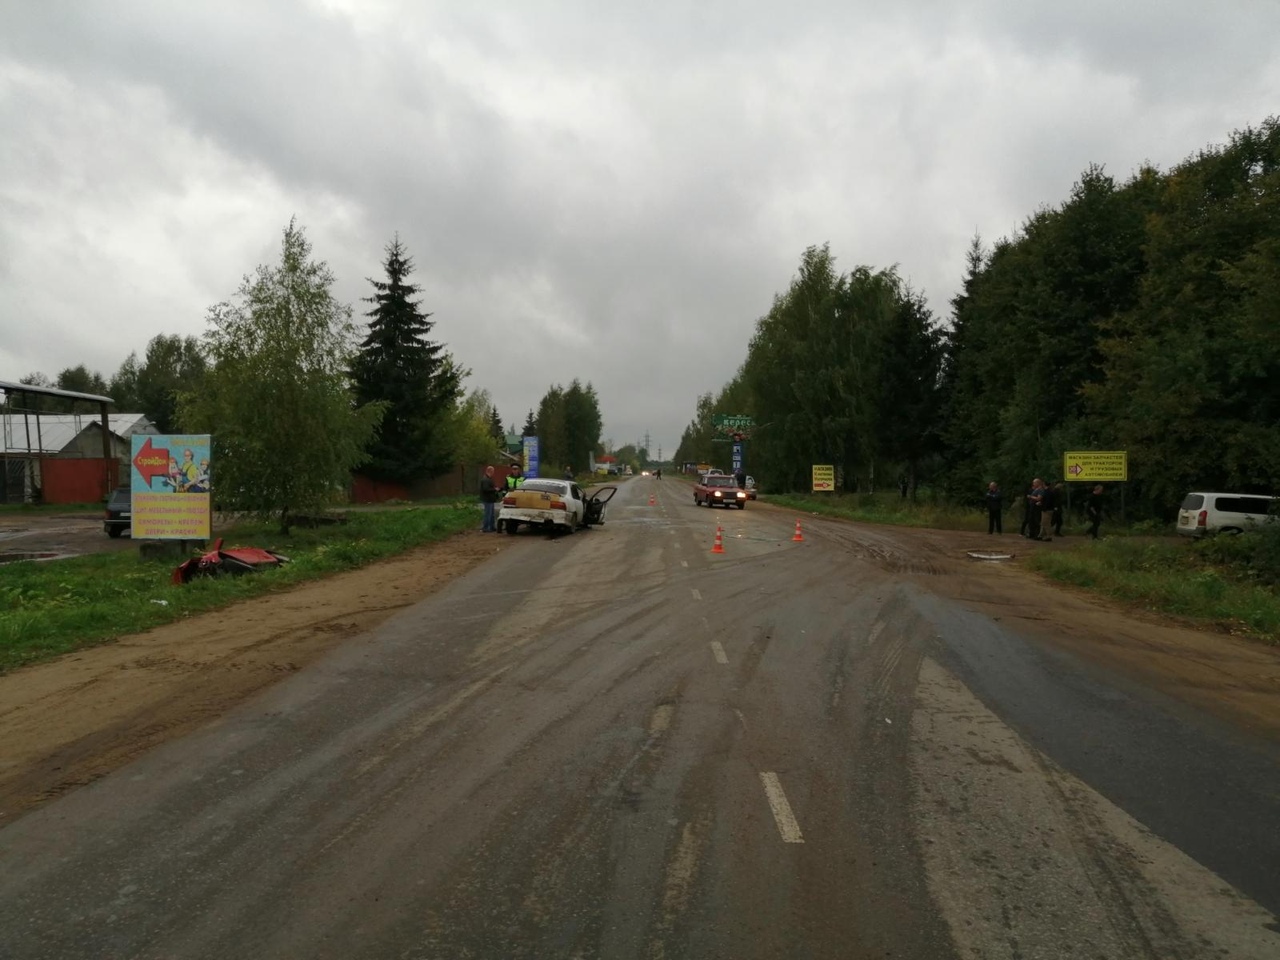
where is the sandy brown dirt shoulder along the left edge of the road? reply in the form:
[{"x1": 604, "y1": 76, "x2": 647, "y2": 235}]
[{"x1": 0, "y1": 532, "x2": 497, "y2": 824}]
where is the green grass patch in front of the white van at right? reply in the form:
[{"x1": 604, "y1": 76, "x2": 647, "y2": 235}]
[{"x1": 1028, "y1": 536, "x2": 1280, "y2": 644}]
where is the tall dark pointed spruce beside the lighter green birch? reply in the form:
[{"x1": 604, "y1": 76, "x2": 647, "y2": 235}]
[{"x1": 351, "y1": 236, "x2": 461, "y2": 483}]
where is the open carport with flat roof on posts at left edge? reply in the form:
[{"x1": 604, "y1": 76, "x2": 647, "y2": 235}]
[{"x1": 0, "y1": 380, "x2": 118, "y2": 503}]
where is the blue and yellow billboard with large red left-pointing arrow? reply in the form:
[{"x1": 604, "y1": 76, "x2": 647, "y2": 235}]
[{"x1": 129, "y1": 434, "x2": 214, "y2": 540}]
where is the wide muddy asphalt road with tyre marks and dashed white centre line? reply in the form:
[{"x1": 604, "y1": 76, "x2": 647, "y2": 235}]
[{"x1": 0, "y1": 479, "x2": 1280, "y2": 960}]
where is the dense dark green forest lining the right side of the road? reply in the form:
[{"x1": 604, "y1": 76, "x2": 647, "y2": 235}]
[{"x1": 676, "y1": 118, "x2": 1280, "y2": 517}]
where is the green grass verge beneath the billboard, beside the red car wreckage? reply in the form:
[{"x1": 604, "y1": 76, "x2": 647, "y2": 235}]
[{"x1": 0, "y1": 506, "x2": 479, "y2": 673}]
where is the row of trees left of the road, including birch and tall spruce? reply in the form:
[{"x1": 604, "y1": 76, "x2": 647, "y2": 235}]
[{"x1": 6, "y1": 221, "x2": 602, "y2": 530}]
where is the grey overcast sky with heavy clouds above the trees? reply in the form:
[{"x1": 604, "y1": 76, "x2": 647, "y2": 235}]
[{"x1": 0, "y1": 0, "x2": 1280, "y2": 456}]
